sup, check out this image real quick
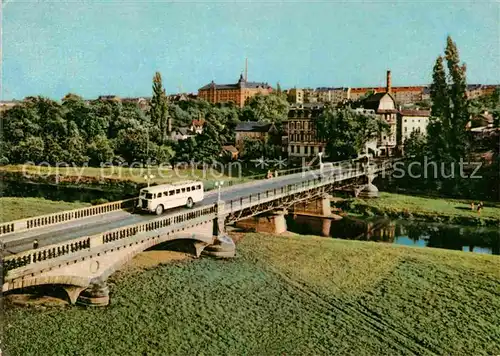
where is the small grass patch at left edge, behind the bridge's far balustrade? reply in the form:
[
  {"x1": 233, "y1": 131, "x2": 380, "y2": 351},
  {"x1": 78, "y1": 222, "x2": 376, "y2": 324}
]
[{"x1": 0, "y1": 198, "x2": 90, "y2": 223}]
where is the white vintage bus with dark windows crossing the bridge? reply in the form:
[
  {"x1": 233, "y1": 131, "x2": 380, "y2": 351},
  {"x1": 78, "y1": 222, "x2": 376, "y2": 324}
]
[{"x1": 137, "y1": 181, "x2": 204, "y2": 215}]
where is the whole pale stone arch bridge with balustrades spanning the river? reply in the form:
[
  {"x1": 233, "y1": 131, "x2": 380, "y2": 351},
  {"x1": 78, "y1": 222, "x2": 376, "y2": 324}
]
[{"x1": 0, "y1": 162, "x2": 388, "y2": 305}]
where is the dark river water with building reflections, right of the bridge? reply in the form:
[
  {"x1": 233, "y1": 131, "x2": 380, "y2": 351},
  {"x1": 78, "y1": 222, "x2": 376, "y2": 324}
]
[{"x1": 324, "y1": 218, "x2": 500, "y2": 255}]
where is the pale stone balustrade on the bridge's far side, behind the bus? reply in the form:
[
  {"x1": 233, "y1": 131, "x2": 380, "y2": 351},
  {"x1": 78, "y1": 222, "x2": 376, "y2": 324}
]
[{"x1": 0, "y1": 198, "x2": 137, "y2": 235}]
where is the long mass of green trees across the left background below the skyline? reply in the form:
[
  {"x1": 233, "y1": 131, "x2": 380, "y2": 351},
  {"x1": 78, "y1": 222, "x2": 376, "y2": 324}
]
[{"x1": 0, "y1": 73, "x2": 288, "y2": 166}]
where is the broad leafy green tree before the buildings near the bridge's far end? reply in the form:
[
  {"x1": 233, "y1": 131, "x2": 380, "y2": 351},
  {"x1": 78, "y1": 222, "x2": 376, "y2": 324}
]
[{"x1": 317, "y1": 106, "x2": 389, "y2": 161}]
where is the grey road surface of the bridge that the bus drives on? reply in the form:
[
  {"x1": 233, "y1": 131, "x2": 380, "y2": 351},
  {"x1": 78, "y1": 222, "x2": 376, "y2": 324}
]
[{"x1": 0, "y1": 168, "x2": 344, "y2": 255}]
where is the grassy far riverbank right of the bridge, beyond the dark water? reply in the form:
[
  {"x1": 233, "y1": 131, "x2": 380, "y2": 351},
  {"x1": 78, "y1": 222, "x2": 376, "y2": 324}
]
[{"x1": 336, "y1": 192, "x2": 500, "y2": 226}]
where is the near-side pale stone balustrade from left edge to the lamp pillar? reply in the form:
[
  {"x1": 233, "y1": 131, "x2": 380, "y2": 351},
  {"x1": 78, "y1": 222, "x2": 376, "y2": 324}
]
[{"x1": 3, "y1": 204, "x2": 217, "y2": 274}]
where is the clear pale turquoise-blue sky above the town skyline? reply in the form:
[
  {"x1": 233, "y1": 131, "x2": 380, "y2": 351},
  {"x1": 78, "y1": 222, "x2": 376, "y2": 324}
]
[{"x1": 2, "y1": 0, "x2": 500, "y2": 100}]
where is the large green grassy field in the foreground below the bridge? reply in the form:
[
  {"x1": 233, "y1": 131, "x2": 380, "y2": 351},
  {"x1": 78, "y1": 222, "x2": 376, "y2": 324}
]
[{"x1": 2, "y1": 234, "x2": 500, "y2": 356}]
